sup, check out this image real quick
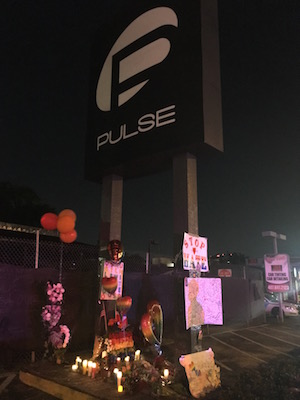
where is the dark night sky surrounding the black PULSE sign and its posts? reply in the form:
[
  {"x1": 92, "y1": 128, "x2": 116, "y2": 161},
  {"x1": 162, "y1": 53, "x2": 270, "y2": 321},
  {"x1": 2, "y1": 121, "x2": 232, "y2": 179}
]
[{"x1": 0, "y1": 0, "x2": 300, "y2": 257}]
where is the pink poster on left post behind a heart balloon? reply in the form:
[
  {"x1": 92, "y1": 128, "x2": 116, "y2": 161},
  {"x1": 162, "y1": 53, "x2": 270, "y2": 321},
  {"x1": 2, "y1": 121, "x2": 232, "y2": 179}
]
[{"x1": 100, "y1": 261, "x2": 124, "y2": 300}]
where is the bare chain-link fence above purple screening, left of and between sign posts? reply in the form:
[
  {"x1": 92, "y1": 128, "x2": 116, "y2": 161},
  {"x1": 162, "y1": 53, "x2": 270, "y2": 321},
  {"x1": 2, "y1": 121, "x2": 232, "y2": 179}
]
[{"x1": 0, "y1": 222, "x2": 146, "y2": 278}]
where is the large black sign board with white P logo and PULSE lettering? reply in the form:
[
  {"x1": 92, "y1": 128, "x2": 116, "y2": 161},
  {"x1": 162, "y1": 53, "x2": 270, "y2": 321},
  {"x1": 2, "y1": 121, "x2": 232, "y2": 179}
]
[{"x1": 86, "y1": 0, "x2": 223, "y2": 181}]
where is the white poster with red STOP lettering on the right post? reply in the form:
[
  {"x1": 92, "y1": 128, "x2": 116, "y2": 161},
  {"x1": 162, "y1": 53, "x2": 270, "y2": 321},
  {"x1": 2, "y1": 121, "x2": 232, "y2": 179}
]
[{"x1": 182, "y1": 232, "x2": 209, "y2": 272}]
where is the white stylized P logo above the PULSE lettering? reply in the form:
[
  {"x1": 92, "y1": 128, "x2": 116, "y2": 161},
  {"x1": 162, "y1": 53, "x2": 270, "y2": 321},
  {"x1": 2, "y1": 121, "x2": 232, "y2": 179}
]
[{"x1": 96, "y1": 7, "x2": 178, "y2": 111}]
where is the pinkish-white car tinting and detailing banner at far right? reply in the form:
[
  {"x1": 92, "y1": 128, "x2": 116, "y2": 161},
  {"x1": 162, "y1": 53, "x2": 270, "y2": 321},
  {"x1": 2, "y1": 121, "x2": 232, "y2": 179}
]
[{"x1": 264, "y1": 254, "x2": 290, "y2": 285}]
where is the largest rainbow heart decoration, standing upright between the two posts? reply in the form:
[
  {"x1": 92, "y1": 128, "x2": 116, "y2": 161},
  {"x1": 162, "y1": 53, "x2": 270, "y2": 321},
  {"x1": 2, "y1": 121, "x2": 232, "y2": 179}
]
[{"x1": 141, "y1": 302, "x2": 163, "y2": 346}]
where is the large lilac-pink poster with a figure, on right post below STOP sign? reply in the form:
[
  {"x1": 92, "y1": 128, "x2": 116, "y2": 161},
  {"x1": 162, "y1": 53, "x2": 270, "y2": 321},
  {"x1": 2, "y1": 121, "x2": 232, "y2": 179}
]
[{"x1": 184, "y1": 278, "x2": 223, "y2": 329}]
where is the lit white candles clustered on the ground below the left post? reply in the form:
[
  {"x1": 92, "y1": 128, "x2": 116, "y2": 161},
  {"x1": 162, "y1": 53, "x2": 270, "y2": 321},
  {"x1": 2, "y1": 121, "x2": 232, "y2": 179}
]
[{"x1": 72, "y1": 350, "x2": 145, "y2": 393}]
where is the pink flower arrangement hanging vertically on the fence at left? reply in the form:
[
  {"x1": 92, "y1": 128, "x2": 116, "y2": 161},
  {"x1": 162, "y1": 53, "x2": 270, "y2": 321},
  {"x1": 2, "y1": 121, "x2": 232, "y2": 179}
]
[{"x1": 41, "y1": 282, "x2": 70, "y2": 363}]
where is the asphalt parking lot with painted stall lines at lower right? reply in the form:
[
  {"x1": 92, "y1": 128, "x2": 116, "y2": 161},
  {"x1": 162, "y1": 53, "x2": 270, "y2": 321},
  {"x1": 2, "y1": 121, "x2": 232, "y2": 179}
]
[{"x1": 203, "y1": 315, "x2": 300, "y2": 377}]
